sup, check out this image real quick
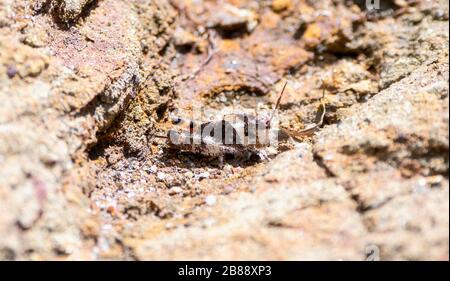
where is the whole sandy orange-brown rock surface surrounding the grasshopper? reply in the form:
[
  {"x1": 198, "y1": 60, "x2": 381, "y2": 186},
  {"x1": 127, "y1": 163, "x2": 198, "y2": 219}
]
[{"x1": 0, "y1": 0, "x2": 449, "y2": 260}]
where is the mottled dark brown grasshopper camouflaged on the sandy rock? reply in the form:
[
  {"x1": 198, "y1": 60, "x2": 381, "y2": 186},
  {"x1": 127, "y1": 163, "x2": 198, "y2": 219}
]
[{"x1": 155, "y1": 83, "x2": 325, "y2": 167}]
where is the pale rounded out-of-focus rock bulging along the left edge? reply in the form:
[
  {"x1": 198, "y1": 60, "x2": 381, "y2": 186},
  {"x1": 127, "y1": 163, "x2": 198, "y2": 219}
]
[{"x1": 0, "y1": 1, "x2": 172, "y2": 259}]
